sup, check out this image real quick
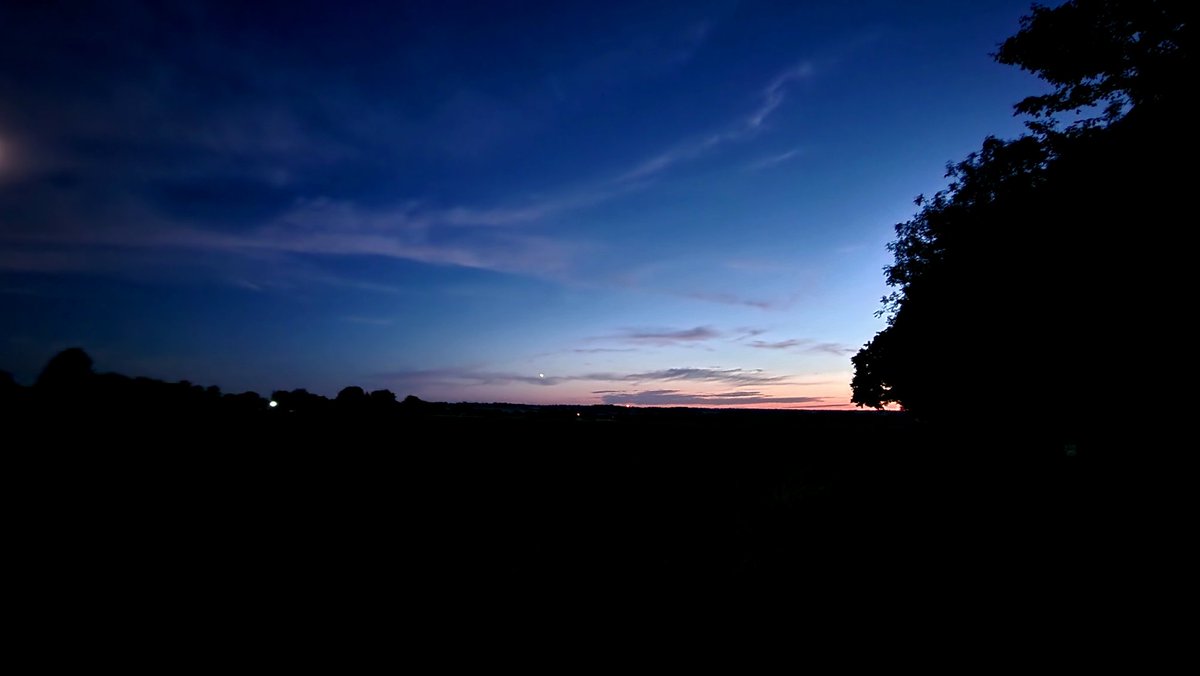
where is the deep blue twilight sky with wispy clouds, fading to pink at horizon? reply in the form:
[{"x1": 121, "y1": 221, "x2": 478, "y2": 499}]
[{"x1": 0, "y1": 0, "x2": 1043, "y2": 408}]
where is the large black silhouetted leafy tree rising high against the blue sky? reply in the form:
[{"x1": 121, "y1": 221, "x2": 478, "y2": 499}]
[{"x1": 852, "y1": 0, "x2": 1195, "y2": 435}]
